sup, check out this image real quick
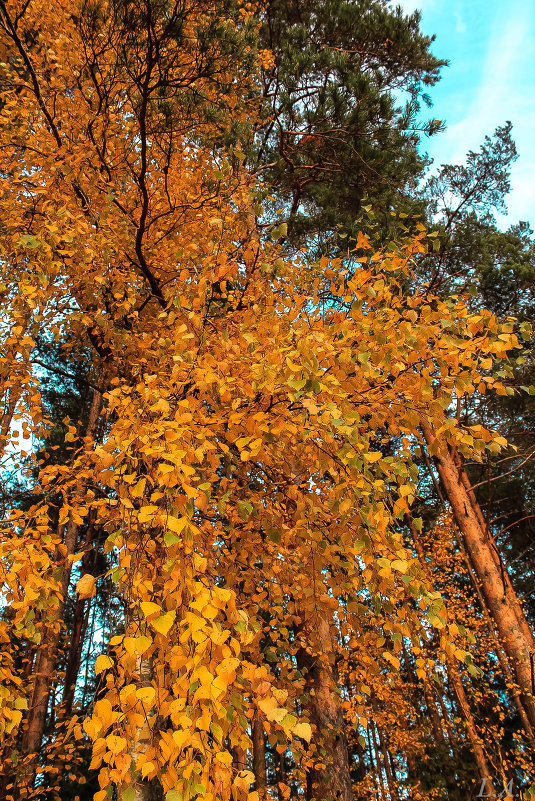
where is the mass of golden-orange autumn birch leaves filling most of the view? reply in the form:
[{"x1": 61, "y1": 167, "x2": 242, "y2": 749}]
[{"x1": 0, "y1": 0, "x2": 535, "y2": 801}]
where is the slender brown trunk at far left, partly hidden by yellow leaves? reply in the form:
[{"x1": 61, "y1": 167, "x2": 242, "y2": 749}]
[{"x1": 22, "y1": 390, "x2": 102, "y2": 784}]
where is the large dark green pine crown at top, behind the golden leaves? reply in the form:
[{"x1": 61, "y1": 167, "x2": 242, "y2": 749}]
[{"x1": 249, "y1": 0, "x2": 446, "y2": 248}]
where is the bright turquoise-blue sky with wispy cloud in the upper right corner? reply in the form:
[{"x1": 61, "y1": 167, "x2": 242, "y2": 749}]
[{"x1": 393, "y1": 0, "x2": 535, "y2": 228}]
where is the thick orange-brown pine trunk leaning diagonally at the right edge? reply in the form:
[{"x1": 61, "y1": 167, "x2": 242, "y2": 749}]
[{"x1": 422, "y1": 423, "x2": 535, "y2": 727}]
